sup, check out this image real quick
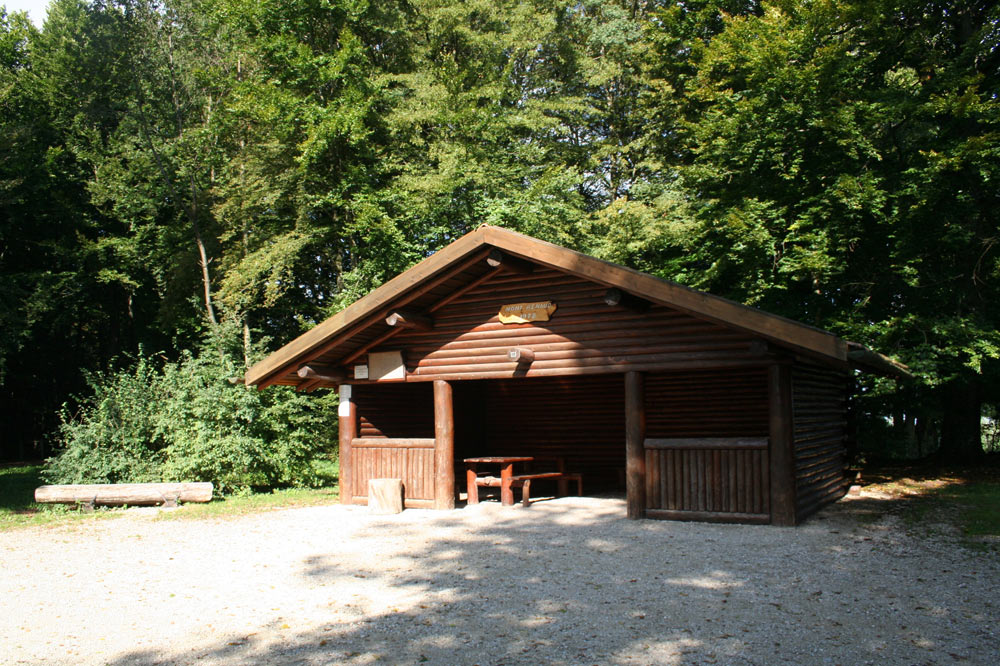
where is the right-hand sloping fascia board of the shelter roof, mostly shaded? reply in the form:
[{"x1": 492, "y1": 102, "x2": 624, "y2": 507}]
[{"x1": 483, "y1": 227, "x2": 847, "y2": 361}]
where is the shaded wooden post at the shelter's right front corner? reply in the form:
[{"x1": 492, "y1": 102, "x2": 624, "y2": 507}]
[{"x1": 767, "y1": 364, "x2": 796, "y2": 525}]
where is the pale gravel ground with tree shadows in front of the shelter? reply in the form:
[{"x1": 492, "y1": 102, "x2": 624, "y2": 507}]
[{"x1": 0, "y1": 496, "x2": 1000, "y2": 666}]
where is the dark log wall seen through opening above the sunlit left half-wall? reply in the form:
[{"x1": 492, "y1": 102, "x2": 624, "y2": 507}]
[{"x1": 352, "y1": 383, "x2": 434, "y2": 438}]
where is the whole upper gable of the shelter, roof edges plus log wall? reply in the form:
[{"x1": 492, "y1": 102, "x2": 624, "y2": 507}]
[{"x1": 245, "y1": 226, "x2": 907, "y2": 390}]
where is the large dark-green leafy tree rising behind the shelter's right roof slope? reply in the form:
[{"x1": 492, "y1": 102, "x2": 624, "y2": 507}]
[{"x1": 668, "y1": 1, "x2": 1000, "y2": 455}]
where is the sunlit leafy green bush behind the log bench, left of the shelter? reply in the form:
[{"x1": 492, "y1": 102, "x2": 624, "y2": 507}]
[{"x1": 45, "y1": 325, "x2": 336, "y2": 494}]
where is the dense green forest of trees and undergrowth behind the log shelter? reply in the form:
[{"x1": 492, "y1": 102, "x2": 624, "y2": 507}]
[{"x1": 0, "y1": 0, "x2": 1000, "y2": 487}]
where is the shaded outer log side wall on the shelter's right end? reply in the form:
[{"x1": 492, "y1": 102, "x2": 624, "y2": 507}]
[{"x1": 792, "y1": 365, "x2": 848, "y2": 521}]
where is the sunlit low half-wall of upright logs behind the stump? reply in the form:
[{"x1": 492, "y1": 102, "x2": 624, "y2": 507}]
[{"x1": 350, "y1": 437, "x2": 434, "y2": 500}]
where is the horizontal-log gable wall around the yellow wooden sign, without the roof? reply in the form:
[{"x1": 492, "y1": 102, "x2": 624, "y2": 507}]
[{"x1": 349, "y1": 267, "x2": 768, "y2": 383}]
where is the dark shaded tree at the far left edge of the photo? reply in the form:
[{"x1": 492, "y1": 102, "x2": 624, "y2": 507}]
[{"x1": 0, "y1": 9, "x2": 133, "y2": 458}]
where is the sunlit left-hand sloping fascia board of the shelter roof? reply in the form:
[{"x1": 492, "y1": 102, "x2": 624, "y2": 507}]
[{"x1": 245, "y1": 227, "x2": 487, "y2": 386}]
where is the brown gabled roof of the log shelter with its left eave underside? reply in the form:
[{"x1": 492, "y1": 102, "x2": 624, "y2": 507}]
[{"x1": 245, "y1": 225, "x2": 909, "y2": 388}]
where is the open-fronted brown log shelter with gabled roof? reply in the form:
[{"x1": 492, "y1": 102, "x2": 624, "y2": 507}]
[{"x1": 245, "y1": 225, "x2": 906, "y2": 525}]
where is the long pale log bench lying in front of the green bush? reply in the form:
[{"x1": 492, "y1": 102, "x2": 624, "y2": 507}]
[{"x1": 35, "y1": 482, "x2": 213, "y2": 509}]
